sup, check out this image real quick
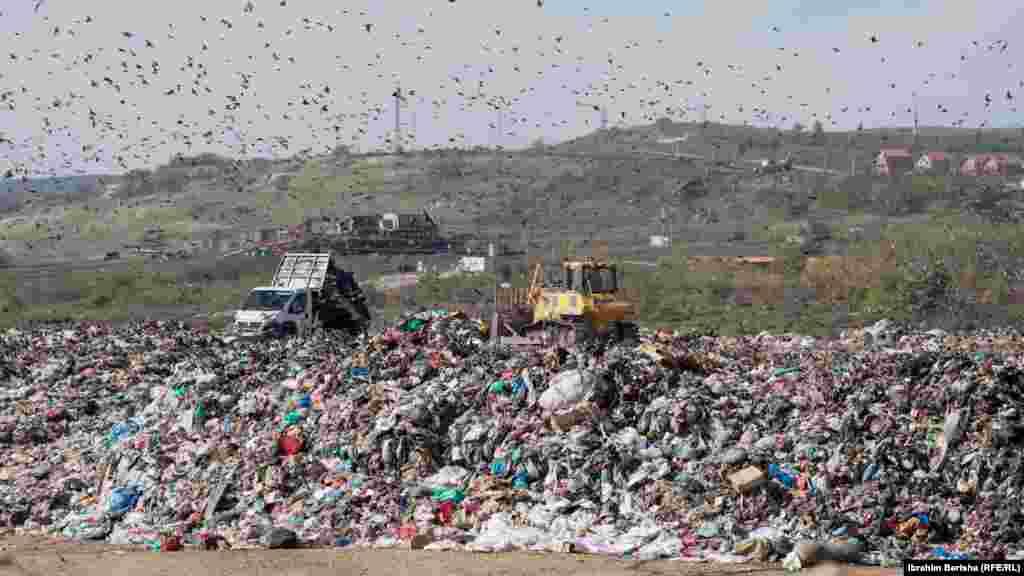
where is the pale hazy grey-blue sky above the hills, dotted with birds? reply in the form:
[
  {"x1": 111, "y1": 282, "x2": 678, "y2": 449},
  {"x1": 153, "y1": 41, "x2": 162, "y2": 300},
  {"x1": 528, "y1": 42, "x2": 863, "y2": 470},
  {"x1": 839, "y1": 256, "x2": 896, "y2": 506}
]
[{"x1": 0, "y1": 0, "x2": 1024, "y2": 176}]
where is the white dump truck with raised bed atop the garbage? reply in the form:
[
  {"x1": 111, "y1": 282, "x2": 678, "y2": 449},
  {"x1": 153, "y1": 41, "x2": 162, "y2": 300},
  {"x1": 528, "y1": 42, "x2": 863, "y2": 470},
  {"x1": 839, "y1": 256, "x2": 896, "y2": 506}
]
[{"x1": 233, "y1": 252, "x2": 370, "y2": 337}]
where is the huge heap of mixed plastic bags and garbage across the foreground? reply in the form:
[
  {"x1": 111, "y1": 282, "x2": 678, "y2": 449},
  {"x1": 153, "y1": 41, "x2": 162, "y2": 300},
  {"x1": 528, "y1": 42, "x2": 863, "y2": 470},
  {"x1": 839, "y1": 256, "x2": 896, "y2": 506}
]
[{"x1": 0, "y1": 312, "x2": 1024, "y2": 568}]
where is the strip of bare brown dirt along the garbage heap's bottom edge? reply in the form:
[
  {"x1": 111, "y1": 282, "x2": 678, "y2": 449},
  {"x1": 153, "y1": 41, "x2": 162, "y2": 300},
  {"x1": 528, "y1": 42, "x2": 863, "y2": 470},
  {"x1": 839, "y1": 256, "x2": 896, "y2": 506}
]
[{"x1": 0, "y1": 536, "x2": 898, "y2": 576}]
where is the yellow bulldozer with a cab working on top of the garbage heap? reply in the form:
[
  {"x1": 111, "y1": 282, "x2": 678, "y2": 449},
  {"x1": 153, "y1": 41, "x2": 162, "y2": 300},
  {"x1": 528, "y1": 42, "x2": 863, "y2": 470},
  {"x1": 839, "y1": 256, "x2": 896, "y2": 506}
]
[{"x1": 503, "y1": 256, "x2": 637, "y2": 348}]
